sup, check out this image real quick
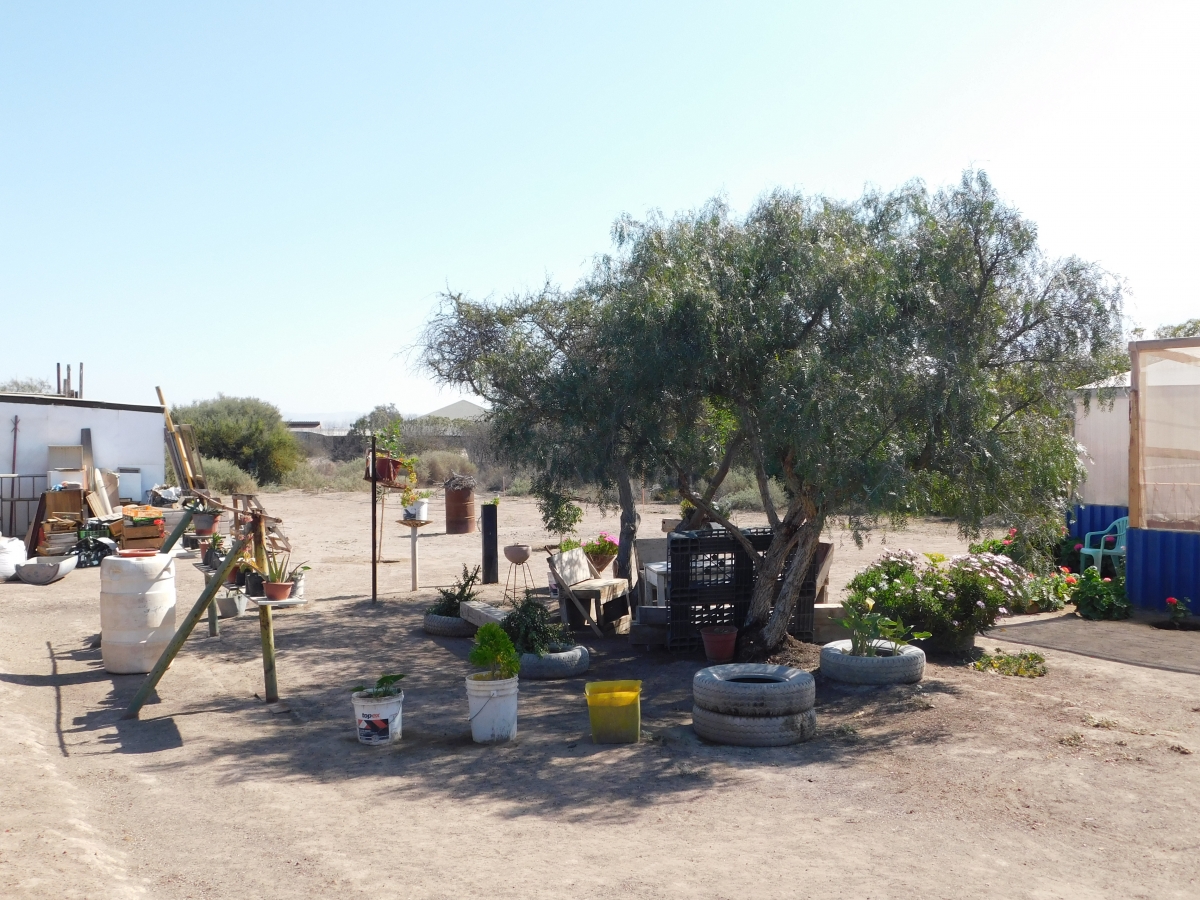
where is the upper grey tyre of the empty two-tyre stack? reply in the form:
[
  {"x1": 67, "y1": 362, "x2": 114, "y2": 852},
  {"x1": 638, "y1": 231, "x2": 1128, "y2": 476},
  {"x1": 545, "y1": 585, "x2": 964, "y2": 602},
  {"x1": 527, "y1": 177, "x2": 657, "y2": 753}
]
[{"x1": 691, "y1": 662, "x2": 817, "y2": 716}]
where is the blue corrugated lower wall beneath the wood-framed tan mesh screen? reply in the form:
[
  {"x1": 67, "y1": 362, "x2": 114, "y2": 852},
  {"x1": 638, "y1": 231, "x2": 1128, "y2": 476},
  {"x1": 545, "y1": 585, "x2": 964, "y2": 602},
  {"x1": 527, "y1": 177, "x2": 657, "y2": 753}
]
[{"x1": 1126, "y1": 528, "x2": 1200, "y2": 613}]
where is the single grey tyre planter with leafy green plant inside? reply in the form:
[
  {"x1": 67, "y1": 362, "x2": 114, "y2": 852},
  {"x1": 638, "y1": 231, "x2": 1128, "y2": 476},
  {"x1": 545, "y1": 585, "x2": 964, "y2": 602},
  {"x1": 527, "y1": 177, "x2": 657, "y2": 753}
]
[{"x1": 821, "y1": 598, "x2": 929, "y2": 684}]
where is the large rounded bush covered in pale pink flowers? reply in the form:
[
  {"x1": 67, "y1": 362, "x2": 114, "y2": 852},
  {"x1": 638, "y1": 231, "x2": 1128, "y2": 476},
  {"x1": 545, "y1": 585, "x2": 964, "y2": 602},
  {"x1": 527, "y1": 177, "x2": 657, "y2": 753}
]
[{"x1": 846, "y1": 550, "x2": 1030, "y2": 643}]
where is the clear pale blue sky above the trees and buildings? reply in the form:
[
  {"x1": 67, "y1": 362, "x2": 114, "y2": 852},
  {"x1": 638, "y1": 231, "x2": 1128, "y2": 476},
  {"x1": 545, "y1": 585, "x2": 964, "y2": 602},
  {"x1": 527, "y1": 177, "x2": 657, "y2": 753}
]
[{"x1": 0, "y1": 0, "x2": 1200, "y2": 419}]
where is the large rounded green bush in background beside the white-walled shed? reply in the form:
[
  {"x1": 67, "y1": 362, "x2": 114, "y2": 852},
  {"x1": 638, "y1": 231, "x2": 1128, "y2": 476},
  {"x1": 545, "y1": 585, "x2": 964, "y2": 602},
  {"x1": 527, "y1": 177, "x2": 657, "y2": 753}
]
[{"x1": 172, "y1": 394, "x2": 304, "y2": 484}]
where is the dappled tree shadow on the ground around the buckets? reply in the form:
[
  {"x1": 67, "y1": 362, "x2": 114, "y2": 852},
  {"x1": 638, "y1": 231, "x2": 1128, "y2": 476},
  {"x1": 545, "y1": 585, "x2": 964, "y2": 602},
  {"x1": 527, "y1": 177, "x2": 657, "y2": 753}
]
[{"x1": 96, "y1": 600, "x2": 950, "y2": 820}]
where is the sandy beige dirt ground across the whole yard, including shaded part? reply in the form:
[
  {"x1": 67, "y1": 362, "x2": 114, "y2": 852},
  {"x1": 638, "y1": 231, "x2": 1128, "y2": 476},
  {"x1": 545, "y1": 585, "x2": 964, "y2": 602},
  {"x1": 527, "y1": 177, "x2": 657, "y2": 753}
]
[{"x1": 0, "y1": 493, "x2": 1200, "y2": 900}]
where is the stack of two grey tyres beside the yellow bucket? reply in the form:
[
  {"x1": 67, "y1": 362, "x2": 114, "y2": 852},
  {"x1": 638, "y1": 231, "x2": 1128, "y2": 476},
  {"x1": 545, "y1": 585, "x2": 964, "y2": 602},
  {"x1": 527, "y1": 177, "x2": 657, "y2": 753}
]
[{"x1": 691, "y1": 662, "x2": 817, "y2": 746}]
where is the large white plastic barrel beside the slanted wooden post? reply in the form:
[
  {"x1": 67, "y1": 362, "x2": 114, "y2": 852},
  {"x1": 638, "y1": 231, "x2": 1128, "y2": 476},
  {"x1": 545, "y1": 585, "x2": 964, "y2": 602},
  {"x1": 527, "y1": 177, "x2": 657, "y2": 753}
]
[{"x1": 100, "y1": 553, "x2": 175, "y2": 674}]
